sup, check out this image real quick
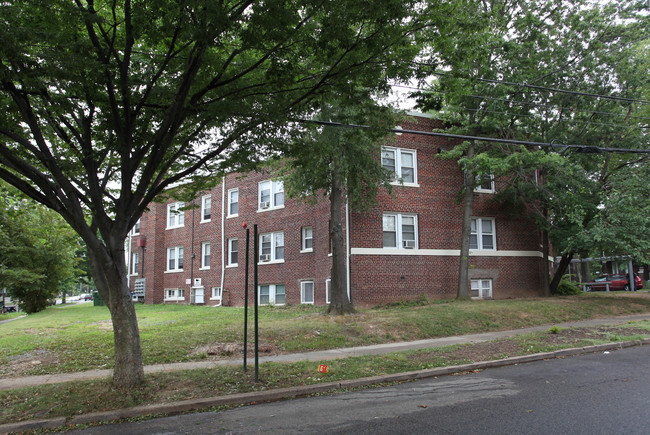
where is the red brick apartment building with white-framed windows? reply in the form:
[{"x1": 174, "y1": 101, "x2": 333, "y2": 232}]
[{"x1": 128, "y1": 115, "x2": 545, "y2": 306}]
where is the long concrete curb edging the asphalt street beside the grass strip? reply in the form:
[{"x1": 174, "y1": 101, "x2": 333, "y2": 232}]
[{"x1": 0, "y1": 338, "x2": 650, "y2": 434}]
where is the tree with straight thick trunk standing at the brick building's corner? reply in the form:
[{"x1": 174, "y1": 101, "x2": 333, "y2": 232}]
[{"x1": 280, "y1": 93, "x2": 396, "y2": 314}]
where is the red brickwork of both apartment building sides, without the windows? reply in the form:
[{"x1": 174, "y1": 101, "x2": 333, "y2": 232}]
[{"x1": 131, "y1": 118, "x2": 543, "y2": 306}]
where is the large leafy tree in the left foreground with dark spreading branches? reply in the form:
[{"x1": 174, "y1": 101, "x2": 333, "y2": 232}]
[{"x1": 0, "y1": 0, "x2": 418, "y2": 387}]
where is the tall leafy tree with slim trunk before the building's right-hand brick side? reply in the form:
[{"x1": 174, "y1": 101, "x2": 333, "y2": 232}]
[{"x1": 422, "y1": 0, "x2": 647, "y2": 299}]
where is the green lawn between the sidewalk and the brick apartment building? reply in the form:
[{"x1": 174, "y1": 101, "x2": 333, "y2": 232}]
[{"x1": 0, "y1": 292, "x2": 650, "y2": 376}]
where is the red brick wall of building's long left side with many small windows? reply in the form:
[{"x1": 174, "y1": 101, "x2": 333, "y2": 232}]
[{"x1": 131, "y1": 173, "x2": 331, "y2": 305}]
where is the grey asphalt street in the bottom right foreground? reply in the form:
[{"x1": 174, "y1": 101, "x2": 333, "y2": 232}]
[{"x1": 72, "y1": 346, "x2": 650, "y2": 435}]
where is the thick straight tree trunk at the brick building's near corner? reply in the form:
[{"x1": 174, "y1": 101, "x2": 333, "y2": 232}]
[{"x1": 327, "y1": 167, "x2": 355, "y2": 315}]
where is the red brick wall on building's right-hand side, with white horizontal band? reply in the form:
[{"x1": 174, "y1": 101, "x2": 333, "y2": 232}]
[{"x1": 350, "y1": 118, "x2": 543, "y2": 304}]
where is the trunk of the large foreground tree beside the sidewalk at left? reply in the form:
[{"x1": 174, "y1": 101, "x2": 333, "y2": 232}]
[{"x1": 88, "y1": 244, "x2": 144, "y2": 388}]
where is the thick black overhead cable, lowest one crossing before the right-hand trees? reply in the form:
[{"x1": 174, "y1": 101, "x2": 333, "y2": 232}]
[{"x1": 298, "y1": 120, "x2": 650, "y2": 154}]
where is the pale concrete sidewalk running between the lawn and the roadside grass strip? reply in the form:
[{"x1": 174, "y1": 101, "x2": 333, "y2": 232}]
[{"x1": 0, "y1": 314, "x2": 650, "y2": 391}]
